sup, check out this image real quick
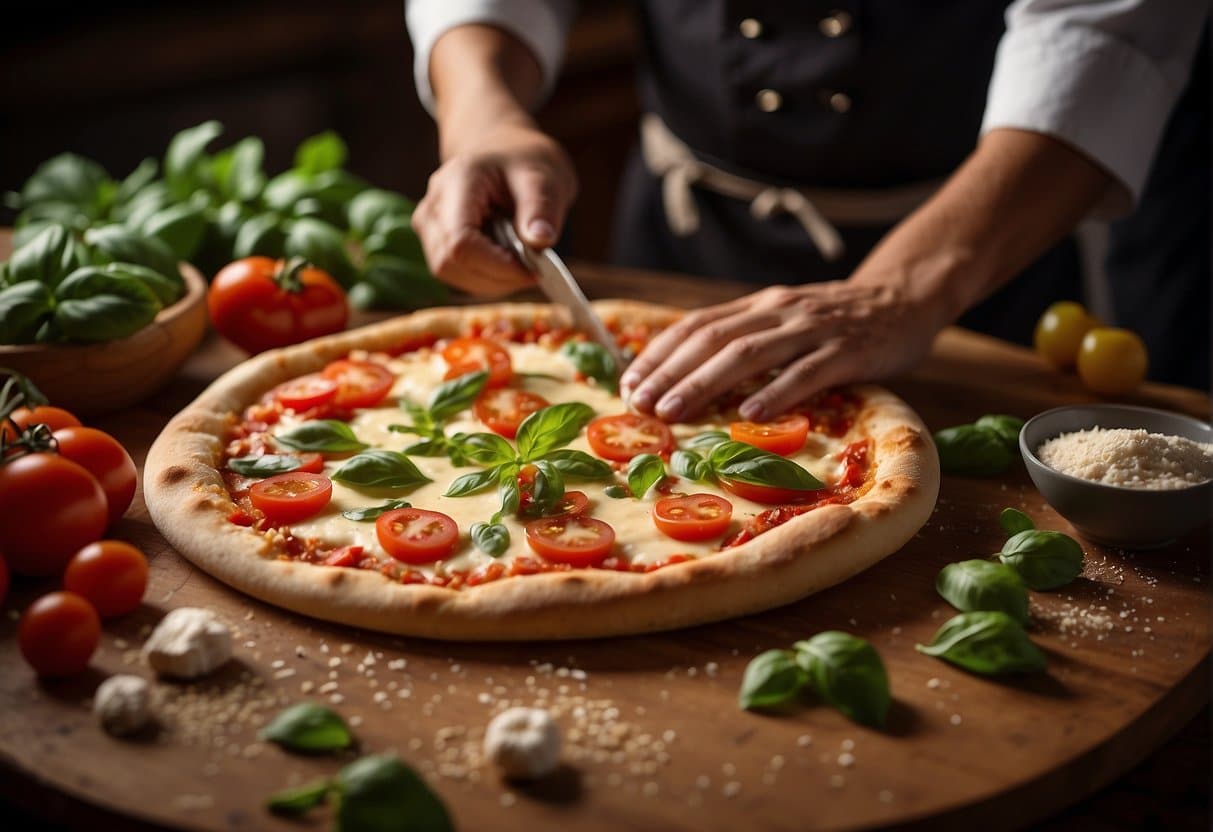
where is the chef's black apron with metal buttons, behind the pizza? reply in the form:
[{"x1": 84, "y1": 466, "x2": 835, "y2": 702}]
[{"x1": 614, "y1": 0, "x2": 1209, "y2": 387}]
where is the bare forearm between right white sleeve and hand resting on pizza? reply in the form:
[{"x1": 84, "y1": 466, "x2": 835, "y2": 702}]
[{"x1": 852, "y1": 130, "x2": 1114, "y2": 327}]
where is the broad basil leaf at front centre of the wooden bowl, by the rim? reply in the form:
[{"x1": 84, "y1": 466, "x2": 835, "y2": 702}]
[{"x1": 53, "y1": 266, "x2": 160, "y2": 342}]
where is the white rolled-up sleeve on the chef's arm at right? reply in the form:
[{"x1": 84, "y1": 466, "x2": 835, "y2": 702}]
[{"x1": 981, "y1": 0, "x2": 1209, "y2": 217}]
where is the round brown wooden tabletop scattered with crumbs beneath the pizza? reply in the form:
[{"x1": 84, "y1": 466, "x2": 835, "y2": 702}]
[{"x1": 0, "y1": 261, "x2": 1209, "y2": 830}]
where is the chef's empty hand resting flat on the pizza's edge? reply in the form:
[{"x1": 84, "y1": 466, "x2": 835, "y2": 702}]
[{"x1": 621, "y1": 280, "x2": 939, "y2": 422}]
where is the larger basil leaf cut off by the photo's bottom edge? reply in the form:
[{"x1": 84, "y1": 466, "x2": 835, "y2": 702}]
[{"x1": 334, "y1": 756, "x2": 455, "y2": 832}]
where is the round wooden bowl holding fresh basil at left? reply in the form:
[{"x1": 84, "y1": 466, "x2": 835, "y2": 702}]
[{"x1": 0, "y1": 263, "x2": 207, "y2": 414}]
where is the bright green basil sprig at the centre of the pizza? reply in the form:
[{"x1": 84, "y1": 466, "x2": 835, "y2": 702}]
[{"x1": 444, "y1": 401, "x2": 614, "y2": 557}]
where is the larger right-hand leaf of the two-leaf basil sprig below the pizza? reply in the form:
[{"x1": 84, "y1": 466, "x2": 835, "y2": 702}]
[{"x1": 793, "y1": 629, "x2": 893, "y2": 728}]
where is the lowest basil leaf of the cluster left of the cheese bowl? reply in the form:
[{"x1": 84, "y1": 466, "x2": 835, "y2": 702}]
[{"x1": 915, "y1": 611, "x2": 1044, "y2": 676}]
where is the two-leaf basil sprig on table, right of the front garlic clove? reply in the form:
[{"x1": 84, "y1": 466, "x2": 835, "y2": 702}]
[{"x1": 738, "y1": 631, "x2": 893, "y2": 728}]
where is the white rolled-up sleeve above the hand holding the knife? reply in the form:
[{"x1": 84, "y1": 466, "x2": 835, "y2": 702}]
[{"x1": 404, "y1": 0, "x2": 577, "y2": 113}]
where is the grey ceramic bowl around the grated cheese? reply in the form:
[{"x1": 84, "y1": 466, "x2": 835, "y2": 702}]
[{"x1": 1019, "y1": 404, "x2": 1213, "y2": 548}]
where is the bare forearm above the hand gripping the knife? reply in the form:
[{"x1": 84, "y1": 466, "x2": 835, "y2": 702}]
[{"x1": 429, "y1": 24, "x2": 543, "y2": 159}]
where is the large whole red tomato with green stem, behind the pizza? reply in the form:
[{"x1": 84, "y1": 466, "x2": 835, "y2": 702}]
[{"x1": 206, "y1": 257, "x2": 349, "y2": 353}]
